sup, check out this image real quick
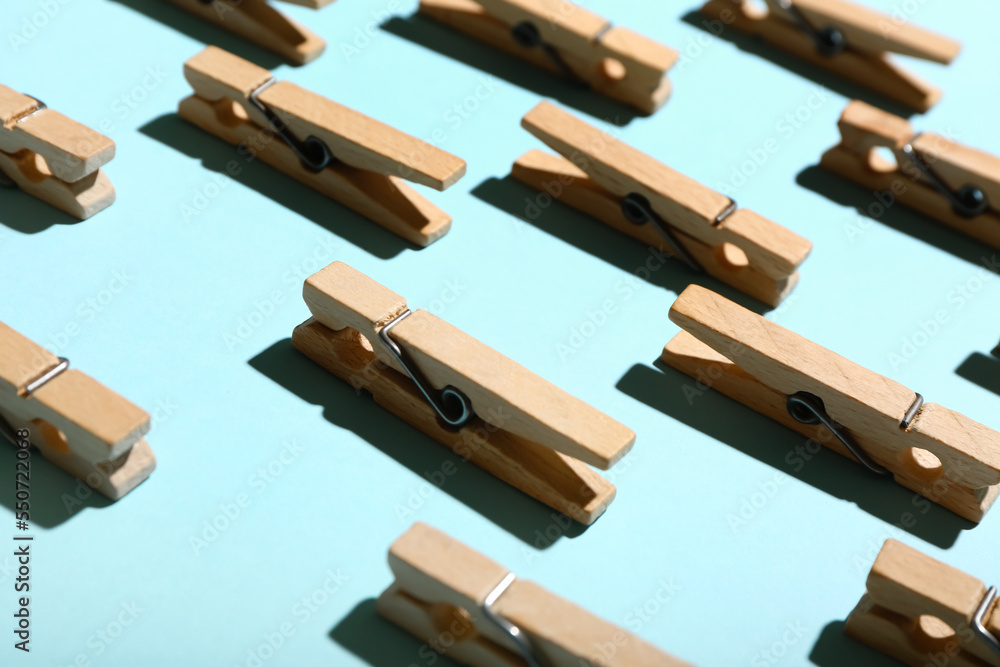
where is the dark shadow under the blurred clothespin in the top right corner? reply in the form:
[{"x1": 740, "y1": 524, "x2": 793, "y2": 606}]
[{"x1": 680, "y1": 10, "x2": 917, "y2": 118}]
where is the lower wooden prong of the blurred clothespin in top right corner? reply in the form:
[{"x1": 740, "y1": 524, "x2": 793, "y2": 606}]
[{"x1": 701, "y1": 0, "x2": 941, "y2": 111}]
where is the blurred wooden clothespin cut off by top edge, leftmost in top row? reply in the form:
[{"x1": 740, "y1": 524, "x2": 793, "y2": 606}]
[{"x1": 171, "y1": 0, "x2": 335, "y2": 65}]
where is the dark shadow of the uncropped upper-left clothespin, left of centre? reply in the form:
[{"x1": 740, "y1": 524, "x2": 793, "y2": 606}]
[{"x1": 139, "y1": 113, "x2": 408, "y2": 259}]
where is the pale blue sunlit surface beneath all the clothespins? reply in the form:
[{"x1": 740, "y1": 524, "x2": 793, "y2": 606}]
[{"x1": 0, "y1": 0, "x2": 1000, "y2": 667}]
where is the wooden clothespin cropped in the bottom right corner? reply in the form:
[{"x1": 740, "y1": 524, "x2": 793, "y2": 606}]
[{"x1": 845, "y1": 540, "x2": 1000, "y2": 667}]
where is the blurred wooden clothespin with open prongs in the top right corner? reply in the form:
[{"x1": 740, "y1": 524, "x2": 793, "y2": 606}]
[{"x1": 701, "y1": 0, "x2": 962, "y2": 111}]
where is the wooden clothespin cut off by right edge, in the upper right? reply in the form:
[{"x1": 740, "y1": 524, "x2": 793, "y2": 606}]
[{"x1": 820, "y1": 100, "x2": 1000, "y2": 248}]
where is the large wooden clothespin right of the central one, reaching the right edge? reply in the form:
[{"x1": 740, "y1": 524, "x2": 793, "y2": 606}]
[{"x1": 663, "y1": 285, "x2": 1000, "y2": 521}]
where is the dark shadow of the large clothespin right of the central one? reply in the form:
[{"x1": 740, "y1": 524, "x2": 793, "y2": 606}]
[{"x1": 617, "y1": 359, "x2": 975, "y2": 549}]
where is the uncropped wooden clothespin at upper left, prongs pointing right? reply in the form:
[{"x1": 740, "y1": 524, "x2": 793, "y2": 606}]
[{"x1": 179, "y1": 46, "x2": 465, "y2": 246}]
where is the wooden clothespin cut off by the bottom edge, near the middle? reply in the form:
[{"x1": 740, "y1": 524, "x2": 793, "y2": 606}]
[{"x1": 377, "y1": 523, "x2": 690, "y2": 667}]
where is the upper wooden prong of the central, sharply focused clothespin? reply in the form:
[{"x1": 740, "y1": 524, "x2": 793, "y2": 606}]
[{"x1": 303, "y1": 262, "x2": 635, "y2": 469}]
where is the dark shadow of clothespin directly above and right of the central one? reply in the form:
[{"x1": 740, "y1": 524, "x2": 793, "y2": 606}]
[{"x1": 472, "y1": 174, "x2": 772, "y2": 314}]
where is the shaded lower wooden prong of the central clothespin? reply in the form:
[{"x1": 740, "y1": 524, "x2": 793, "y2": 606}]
[{"x1": 292, "y1": 319, "x2": 615, "y2": 525}]
